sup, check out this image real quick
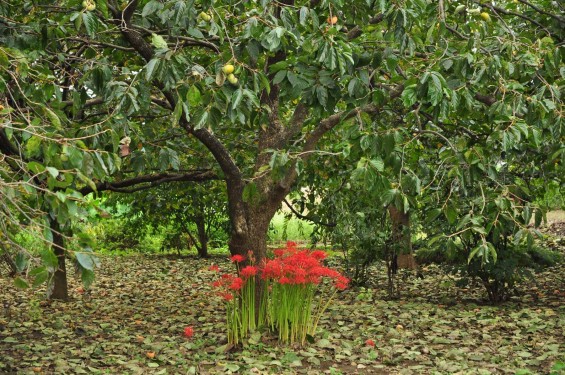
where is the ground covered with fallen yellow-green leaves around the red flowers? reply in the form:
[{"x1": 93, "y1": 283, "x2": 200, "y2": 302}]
[{"x1": 0, "y1": 235, "x2": 565, "y2": 374}]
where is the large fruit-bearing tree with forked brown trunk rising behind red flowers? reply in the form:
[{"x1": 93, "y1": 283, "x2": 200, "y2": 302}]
[{"x1": 0, "y1": 0, "x2": 564, "y2": 308}]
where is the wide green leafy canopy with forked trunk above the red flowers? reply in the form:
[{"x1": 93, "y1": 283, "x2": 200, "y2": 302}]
[{"x1": 0, "y1": 0, "x2": 565, "y2": 300}]
